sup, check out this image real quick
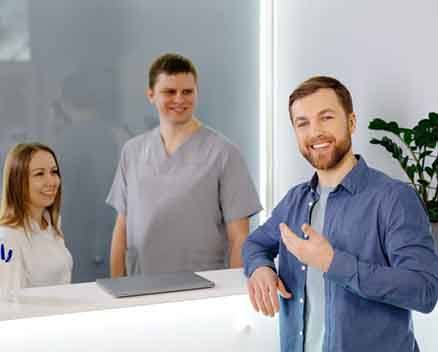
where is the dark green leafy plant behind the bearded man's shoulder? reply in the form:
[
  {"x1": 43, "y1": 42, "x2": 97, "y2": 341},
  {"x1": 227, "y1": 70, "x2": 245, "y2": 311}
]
[{"x1": 368, "y1": 112, "x2": 438, "y2": 252}]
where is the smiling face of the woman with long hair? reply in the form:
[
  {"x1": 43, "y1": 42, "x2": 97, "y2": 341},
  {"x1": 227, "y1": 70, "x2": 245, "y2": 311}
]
[{"x1": 29, "y1": 150, "x2": 61, "y2": 209}]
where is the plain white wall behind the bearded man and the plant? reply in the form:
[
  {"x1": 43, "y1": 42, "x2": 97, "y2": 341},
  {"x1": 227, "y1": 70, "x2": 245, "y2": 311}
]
[{"x1": 273, "y1": 0, "x2": 438, "y2": 199}]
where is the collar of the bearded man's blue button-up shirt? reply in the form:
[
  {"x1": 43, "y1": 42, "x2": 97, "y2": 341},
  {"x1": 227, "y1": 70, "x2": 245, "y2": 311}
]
[{"x1": 308, "y1": 154, "x2": 368, "y2": 194}]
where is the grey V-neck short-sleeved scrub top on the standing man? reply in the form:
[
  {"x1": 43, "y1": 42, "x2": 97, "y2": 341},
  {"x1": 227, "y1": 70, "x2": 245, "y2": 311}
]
[{"x1": 107, "y1": 126, "x2": 262, "y2": 275}]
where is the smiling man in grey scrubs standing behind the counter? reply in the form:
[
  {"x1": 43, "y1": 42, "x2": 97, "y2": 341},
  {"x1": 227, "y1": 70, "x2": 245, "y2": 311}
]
[{"x1": 107, "y1": 54, "x2": 261, "y2": 277}]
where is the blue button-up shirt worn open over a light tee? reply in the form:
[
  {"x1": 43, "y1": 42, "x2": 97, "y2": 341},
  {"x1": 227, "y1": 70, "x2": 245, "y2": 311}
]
[{"x1": 242, "y1": 156, "x2": 438, "y2": 352}]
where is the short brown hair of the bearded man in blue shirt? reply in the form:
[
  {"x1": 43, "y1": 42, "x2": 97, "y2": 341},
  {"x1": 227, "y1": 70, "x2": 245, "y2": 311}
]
[{"x1": 289, "y1": 76, "x2": 353, "y2": 118}]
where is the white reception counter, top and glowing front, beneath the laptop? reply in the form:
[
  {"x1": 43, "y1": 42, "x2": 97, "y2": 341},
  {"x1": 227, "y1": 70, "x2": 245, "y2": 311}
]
[{"x1": 0, "y1": 270, "x2": 438, "y2": 352}]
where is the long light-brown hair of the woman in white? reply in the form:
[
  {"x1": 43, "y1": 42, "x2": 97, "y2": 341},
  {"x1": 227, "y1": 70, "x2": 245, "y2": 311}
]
[{"x1": 0, "y1": 143, "x2": 63, "y2": 237}]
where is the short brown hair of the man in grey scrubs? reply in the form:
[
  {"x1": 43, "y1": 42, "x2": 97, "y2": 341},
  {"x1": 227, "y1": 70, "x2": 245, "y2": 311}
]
[{"x1": 149, "y1": 53, "x2": 198, "y2": 89}]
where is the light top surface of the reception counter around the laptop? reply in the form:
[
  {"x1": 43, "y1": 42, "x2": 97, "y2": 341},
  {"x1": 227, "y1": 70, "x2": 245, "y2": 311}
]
[{"x1": 0, "y1": 269, "x2": 246, "y2": 321}]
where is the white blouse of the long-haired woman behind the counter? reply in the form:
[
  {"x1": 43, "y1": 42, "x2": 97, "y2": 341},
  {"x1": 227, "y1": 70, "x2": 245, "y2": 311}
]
[{"x1": 0, "y1": 217, "x2": 73, "y2": 290}]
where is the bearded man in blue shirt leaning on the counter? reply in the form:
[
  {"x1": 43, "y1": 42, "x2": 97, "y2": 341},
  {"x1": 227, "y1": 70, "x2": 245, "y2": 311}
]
[{"x1": 242, "y1": 76, "x2": 438, "y2": 352}]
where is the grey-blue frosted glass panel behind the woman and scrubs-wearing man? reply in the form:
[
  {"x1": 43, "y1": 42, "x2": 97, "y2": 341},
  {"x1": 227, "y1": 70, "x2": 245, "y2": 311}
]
[{"x1": 0, "y1": 0, "x2": 258, "y2": 282}]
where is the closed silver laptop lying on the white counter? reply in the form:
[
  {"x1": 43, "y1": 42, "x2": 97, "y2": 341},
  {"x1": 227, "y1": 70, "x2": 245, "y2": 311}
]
[{"x1": 96, "y1": 272, "x2": 214, "y2": 298}]
